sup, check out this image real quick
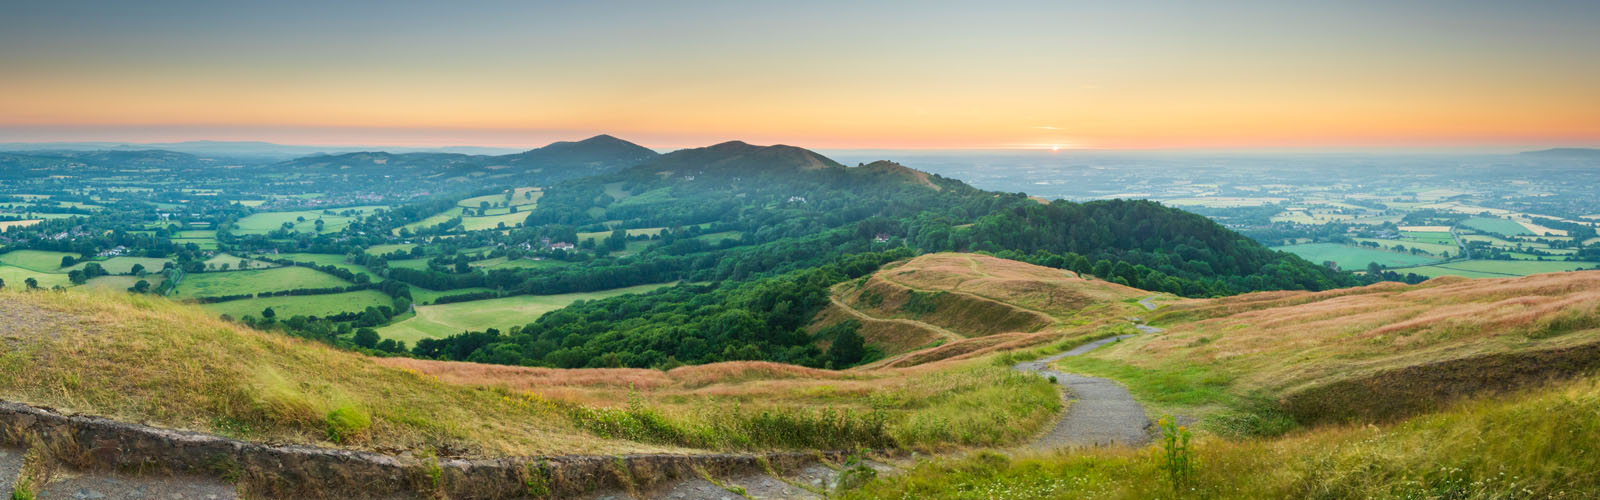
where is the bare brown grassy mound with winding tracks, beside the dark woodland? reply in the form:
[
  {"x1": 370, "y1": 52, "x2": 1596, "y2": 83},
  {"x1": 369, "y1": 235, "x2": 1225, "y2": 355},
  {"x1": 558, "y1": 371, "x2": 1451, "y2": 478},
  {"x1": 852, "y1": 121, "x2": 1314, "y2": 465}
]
[{"x1": 811, "y1": 253, "x2": 1152, "y2": 367}]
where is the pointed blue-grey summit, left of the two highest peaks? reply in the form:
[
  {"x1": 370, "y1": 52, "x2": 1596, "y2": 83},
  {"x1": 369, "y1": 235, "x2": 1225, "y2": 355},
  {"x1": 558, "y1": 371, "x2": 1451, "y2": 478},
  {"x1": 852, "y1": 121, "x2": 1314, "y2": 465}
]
[{"x1": 496, "y1": 135, "x2": 659, "y2": 179}]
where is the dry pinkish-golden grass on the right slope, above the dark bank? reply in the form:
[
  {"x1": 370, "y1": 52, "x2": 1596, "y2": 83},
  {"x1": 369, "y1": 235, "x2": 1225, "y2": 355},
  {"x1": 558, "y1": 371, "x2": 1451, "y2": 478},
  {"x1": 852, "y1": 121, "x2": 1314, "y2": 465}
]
[{"x1": 1066, "y1": 271, "x2": 1600, "y2": 423}]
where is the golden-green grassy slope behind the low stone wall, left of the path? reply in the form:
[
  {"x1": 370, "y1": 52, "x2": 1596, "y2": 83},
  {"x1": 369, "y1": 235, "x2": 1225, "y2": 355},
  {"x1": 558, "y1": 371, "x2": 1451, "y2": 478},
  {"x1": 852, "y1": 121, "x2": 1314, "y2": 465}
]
[{"x1": 0, "y1": 287, "x2": 1061, "y2": 457}]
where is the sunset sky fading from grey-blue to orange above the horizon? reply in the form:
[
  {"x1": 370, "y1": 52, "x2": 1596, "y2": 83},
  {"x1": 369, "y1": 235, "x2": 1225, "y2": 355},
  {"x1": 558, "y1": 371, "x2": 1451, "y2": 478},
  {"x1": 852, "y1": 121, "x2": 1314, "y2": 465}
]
[{"x1": 0, "y1": 0, "x2": 1600, "y2": 149}]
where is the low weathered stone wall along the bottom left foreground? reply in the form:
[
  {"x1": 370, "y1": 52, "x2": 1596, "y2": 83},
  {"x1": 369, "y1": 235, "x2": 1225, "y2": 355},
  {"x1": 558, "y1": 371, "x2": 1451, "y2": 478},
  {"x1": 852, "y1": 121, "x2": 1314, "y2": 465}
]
[{"x1": 0, "y1": 402, "x2": 845, "y2": 498}]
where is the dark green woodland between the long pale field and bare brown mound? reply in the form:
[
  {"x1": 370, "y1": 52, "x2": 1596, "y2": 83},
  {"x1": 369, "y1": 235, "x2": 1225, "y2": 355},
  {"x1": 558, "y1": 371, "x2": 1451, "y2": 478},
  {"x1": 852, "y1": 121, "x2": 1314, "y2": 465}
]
[{"x1": 413, "y1": 248, "x2": 912, "y2": 369}]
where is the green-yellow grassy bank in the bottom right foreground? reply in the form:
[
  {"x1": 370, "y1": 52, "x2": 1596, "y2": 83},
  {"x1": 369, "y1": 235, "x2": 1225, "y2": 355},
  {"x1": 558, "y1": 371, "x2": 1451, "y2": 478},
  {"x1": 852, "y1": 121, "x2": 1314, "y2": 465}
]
[{"x1": 837, "y1": 378, "x2": 1600, "y2": 500}]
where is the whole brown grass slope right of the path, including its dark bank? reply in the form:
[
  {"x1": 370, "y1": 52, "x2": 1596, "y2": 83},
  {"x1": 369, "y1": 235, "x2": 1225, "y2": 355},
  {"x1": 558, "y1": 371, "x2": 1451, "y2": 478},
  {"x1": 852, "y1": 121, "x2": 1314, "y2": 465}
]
[{"x1": 1074, "y1": 271, "x2": 1600, "y2": 421}]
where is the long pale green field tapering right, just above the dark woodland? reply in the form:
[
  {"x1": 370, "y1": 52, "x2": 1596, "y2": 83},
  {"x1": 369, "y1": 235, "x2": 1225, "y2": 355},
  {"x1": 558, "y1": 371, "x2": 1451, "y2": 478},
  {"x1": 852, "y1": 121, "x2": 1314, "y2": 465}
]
[{"x1": 378, "y1": 284, "x2": 669, "y2": 345}]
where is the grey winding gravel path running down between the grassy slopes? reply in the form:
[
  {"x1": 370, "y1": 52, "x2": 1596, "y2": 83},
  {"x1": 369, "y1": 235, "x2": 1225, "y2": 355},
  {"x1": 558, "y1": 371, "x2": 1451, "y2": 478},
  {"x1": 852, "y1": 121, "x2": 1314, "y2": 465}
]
[{"x1": 1014, "y1": 296, "x2": 1162, "y2": 450}]
